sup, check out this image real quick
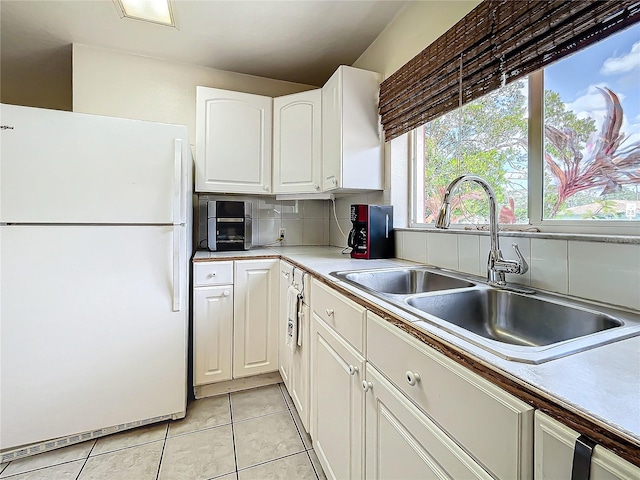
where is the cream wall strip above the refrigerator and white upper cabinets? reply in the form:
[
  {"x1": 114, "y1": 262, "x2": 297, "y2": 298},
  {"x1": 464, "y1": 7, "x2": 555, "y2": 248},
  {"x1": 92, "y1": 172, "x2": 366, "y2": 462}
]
[{"x1": 73, "y1": 44, "x2": 317, "y2": 145}]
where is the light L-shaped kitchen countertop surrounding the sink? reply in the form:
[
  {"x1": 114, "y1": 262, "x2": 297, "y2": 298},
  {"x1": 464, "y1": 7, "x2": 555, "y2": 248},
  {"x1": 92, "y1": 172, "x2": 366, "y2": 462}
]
[{"x1": 194, "y1": 246, "x2": 640, "y2": 463}]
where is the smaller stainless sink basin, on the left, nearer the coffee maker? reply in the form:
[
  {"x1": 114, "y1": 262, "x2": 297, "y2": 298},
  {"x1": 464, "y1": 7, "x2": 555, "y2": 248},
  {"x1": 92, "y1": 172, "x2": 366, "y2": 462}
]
[{"x1": 335, "y1": 268, "x2": 475, "y2": 295}]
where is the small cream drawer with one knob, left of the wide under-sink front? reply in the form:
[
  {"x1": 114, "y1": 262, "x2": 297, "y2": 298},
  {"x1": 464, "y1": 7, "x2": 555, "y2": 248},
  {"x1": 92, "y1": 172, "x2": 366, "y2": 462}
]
[{"x1": 311, "y1": 280, "x2": 365, "y2": 352}]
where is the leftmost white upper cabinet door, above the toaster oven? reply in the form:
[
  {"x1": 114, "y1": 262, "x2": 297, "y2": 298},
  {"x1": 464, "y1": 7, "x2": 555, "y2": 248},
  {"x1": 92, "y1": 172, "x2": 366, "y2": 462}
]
[{"x1": 196, "y1": 87, "x2": 272, "y2": 193}]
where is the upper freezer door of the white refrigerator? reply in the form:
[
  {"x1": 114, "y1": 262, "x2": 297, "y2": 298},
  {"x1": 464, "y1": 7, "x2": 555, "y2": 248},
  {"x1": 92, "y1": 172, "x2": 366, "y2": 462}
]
[{"x1": 0, "y1": 105, "x2": 191, "y2": 224}]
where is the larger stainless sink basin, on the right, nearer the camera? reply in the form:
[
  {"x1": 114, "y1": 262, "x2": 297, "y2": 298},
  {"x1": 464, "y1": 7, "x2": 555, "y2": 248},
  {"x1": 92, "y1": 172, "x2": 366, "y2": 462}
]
[{"x1": 407, "y1": 289, "x2": 623, "y2": 347}]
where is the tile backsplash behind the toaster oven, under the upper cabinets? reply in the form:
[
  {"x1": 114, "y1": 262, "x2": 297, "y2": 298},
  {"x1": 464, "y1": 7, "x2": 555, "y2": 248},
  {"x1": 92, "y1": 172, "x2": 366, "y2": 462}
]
[{"x1": 195, "y1": 194, "x2": 331, "y2": 248}]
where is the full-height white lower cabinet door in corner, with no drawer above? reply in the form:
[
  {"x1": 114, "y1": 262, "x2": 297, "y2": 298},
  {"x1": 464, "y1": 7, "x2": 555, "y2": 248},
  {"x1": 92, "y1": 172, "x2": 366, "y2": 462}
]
[{"x1": 233, "y1": 259, "x2": 280, "y2": 378}]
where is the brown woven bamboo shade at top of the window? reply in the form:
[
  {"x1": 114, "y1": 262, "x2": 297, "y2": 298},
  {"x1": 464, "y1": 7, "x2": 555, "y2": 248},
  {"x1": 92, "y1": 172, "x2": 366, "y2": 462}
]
[{"x1": 379, "y1": 0, "x2": 640, "y2": 141}]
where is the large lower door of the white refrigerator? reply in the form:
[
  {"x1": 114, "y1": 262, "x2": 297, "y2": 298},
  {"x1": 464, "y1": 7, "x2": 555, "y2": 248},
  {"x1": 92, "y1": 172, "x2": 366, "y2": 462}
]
[{"x1": 0, "y1": 226, "x2": 189, "y2": 449}]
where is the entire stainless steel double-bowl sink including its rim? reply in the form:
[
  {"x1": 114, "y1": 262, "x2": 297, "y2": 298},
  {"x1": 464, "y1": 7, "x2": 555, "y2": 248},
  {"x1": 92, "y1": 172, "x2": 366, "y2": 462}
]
[{"x1": 331, "y1": 267, "x2": 640, "y2": 363}]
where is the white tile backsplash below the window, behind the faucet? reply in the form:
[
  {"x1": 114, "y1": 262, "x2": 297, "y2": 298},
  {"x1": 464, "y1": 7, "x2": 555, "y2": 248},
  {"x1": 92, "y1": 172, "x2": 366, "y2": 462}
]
[{"x1": 396, "y1": 229, "x2": 640, "y2": 310}]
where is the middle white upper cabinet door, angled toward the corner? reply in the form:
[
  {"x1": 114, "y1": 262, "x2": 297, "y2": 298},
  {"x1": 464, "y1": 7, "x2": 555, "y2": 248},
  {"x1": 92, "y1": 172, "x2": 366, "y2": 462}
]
[{"x1": 273, "y1": 89, "x2": 322, "y2": 193}]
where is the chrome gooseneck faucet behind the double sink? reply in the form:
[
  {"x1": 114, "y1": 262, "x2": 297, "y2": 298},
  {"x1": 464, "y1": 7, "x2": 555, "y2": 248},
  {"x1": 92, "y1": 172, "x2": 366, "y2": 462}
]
[{"x1": 436, "y1": 175, "x2": 529, "y2": 288}]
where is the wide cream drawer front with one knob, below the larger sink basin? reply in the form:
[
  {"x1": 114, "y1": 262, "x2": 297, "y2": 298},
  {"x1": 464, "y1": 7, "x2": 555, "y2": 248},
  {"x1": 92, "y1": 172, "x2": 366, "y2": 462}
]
[{"x1": 367, "y1": 312, "x2": 533, "y2": 479}]
